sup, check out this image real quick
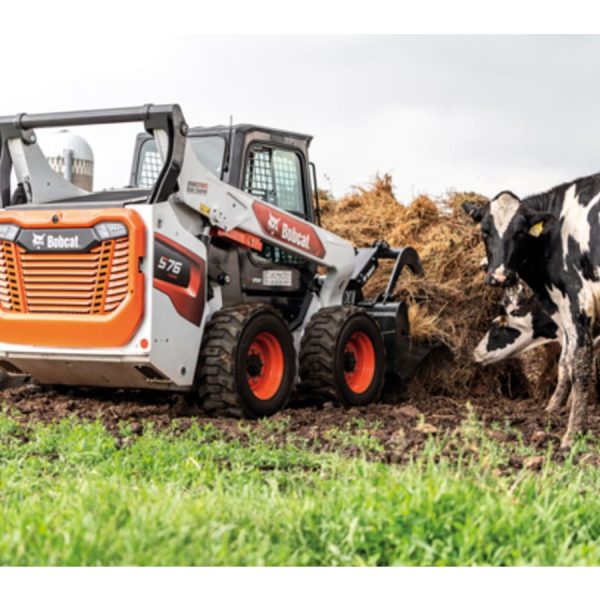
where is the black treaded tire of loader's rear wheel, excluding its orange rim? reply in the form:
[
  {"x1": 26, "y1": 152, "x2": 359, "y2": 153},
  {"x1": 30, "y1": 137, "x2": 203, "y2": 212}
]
[{"x1": 198, "y1": 304, "x2": 296, "y2": 419}]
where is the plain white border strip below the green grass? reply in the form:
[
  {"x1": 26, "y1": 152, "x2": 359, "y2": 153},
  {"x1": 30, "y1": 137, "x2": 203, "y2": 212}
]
[{"x1": 0, "y1": 567, "x2": 598, "y2": 600}]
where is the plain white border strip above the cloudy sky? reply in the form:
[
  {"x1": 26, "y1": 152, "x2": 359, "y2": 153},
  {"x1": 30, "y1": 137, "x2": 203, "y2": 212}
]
[{"x1": 0, "y1": 0, "x2": 598, "y2": 33}]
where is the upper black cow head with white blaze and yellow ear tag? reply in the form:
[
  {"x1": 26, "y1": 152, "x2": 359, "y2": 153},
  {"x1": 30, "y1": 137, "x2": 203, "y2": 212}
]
[{"x1": 462, "y1": 192, "x2": 556, "y2": 287}]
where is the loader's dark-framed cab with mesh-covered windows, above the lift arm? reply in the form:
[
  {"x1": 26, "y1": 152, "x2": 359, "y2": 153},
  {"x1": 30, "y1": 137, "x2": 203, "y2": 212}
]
[{"x1": 130, "y1": 124, "x2": 315, "y2": 222}]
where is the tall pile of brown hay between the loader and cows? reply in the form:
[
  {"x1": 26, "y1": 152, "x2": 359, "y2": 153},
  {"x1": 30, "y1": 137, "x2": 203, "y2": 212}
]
[{"x1": 322, "y1": 175, "x2": 526, "y2": 396}]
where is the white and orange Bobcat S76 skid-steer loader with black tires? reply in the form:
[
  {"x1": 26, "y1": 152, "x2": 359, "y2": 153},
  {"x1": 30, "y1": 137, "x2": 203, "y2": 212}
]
[{"x1": 0, "y1": 105, "x2": 422, "y2": 418}]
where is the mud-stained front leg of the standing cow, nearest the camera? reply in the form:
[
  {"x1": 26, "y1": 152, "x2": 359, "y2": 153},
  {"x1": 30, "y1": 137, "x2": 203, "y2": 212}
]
[{"x1": 561, "y1": 326, "x2": 594, "y2": 448}]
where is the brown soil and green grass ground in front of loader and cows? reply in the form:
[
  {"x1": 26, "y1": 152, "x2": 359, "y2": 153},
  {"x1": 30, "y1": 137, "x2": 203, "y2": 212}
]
[{"x1": 0, "y1": 386, "x2": 600, "y2": 565}]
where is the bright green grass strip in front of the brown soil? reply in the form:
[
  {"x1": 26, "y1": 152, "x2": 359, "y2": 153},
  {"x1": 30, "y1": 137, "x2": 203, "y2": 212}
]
[{"x1": 0, "y1": 414, "x2": 600, "y2": 565}]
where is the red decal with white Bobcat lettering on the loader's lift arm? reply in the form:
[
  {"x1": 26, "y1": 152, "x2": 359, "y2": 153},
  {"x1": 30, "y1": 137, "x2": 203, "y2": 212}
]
[{"x1": 252, "y1": 202, "x2": 325, "y2": 258}]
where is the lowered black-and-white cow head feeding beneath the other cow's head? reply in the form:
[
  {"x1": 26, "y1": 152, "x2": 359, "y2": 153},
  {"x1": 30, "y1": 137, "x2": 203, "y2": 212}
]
[{"x1": 473, "y1": 282, "x2": 559, "y2": 365}]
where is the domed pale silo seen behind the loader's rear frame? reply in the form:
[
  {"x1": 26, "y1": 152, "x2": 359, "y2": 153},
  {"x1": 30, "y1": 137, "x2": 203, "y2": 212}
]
[{"x1": 41, "y1": 129, "x2": 94, "y2": 192}]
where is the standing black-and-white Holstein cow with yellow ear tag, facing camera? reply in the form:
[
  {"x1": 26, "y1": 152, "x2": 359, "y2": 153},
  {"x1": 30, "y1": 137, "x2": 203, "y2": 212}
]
[{"x1": 463, "y1": 174, "x2": 600, "y2": 446}]
